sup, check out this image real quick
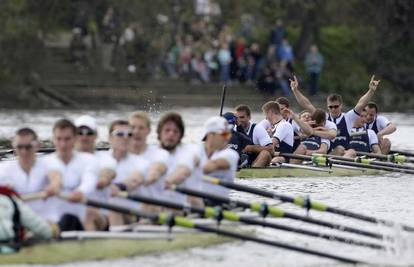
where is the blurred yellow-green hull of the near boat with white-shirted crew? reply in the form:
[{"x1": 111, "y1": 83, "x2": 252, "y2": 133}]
[{"x1": 0, "y1": 226, "x2": 231, "y2": 265}]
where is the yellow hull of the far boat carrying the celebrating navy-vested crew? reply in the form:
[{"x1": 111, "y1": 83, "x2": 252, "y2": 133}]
[{"x1": 236, "y1": 166, "x2": 381, "y2": 179}]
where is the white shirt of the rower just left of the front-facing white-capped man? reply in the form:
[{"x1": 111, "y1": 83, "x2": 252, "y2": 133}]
[{"x1": 44, "y1": 152, "x2": 99, "y2": 222}]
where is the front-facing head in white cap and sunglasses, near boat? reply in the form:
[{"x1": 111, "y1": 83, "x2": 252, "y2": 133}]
[{"x1": 75, "y1": 115, "x2": 98, "y2": 153}]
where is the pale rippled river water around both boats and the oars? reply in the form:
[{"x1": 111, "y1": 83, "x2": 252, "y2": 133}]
[{"x1": 0, "y1": 108, "x2": 414, "y2": 267}]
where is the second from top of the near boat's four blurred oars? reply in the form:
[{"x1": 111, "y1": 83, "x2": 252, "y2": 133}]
[{"x1": 174, "y1": 186, "x2": 383, "y2": 240}]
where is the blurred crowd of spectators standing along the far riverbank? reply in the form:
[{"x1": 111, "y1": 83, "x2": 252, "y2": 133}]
[{"x1": 67, "y1": 4, "x2": 323, "y2": 95}]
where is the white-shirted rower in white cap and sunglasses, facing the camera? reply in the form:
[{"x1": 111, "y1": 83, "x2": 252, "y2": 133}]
[{"x1": 75, "y1": 115, "x2": 116, "y2": 231}]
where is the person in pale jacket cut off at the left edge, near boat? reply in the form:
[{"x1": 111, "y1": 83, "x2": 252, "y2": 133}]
[{"x1": 0, "y1": 186, "x2": 54, "y2": 255}]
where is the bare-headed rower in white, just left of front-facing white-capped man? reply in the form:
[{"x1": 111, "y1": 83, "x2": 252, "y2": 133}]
[{"x1": 45, "y1": 119, "x2": 98, "y2": 231}]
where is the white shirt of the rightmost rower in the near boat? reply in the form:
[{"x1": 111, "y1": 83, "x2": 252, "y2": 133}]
[{"x1": 201, "y1": 146, "x2": 239, "y2": 197}]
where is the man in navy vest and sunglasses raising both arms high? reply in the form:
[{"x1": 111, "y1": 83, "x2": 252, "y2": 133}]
[{"x1": 290, "y1": 75, "x2": 380, "y2": 156}]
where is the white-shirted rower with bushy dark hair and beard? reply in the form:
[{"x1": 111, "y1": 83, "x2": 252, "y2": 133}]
[{"x1": 157, "y1": 112, "x2": 202, "y2": 206}]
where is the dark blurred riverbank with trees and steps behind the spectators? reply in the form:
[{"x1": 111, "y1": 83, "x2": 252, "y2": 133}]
[{"x1": 0, "y1": 0, "x2": 414, "y2": 112}]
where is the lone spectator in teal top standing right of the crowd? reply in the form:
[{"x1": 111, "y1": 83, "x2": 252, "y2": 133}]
[{"x1": 305, "y1": 45, "x2": 323, "y2": 95}]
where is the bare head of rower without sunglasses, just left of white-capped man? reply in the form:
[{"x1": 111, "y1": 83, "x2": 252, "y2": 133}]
[{"x1": 53, "y1": 119, "x2": 76, "y2": 158}]
